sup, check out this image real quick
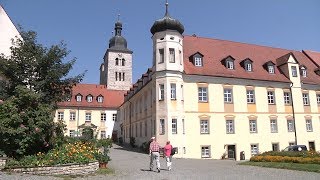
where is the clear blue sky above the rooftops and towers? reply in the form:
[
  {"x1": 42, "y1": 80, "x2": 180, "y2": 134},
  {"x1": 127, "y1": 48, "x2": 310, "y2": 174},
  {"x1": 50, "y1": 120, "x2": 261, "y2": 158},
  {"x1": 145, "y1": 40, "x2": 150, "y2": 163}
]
[{"x1": 0, "y1": 0, "x2": 320, "y2": 84}]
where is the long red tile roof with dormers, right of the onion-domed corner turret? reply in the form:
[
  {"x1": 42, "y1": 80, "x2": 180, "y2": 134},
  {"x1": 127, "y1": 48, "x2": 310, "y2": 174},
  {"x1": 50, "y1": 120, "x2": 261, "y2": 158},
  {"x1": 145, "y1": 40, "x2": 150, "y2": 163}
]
[{"x1": 183, "y1": 35, "x2": 320, "y2": 84}]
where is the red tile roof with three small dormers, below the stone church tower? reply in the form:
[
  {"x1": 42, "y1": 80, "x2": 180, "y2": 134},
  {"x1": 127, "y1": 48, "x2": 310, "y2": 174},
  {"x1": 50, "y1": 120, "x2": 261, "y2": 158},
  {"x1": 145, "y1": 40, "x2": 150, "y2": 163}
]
[{"x1": 58, "y1": 84, "x2": 126, "y2": 109}]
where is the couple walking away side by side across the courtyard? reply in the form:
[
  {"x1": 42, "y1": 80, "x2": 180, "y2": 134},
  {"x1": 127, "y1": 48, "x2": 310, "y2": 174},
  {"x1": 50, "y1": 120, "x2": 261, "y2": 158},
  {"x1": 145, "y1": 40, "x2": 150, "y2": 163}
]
[{"x1": 149, "y1": 137, "x2": 172, "y2": 173}]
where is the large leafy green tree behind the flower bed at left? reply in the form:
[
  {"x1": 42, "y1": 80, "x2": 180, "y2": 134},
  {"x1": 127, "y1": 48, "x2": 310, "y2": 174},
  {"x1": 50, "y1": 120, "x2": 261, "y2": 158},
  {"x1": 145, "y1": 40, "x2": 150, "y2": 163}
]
[{"x1": 0, "y1": 31, "x2": 84, "y2": 158}]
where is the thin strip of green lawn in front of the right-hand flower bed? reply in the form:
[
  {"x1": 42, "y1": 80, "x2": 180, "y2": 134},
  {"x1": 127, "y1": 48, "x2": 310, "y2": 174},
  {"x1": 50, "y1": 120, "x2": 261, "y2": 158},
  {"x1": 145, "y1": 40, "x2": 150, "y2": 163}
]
[{"x1": 239, "y1": 161, "x2": 320, "y2": 173}]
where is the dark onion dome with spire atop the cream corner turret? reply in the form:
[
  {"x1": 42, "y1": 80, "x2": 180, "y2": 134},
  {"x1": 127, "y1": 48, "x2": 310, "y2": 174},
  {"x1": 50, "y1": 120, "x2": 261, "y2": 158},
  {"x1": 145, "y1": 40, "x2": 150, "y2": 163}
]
[{"x1": 150, "y1": 3, "x2": 184, "y2": 35}]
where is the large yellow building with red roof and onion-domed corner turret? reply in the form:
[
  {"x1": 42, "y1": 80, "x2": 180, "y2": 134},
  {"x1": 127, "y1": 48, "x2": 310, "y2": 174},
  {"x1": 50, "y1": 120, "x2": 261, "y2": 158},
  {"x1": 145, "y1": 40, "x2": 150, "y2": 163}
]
[{"x1": 117, "y1": 3, "x2": 320, "y2": 160}]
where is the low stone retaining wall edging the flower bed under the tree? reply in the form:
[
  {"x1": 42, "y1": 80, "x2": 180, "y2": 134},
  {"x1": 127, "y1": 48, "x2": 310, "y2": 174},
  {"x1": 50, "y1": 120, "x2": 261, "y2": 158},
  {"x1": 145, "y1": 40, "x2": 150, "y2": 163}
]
[{"x1": 10, "y1": 162, "x2": 99, "y2": 175}]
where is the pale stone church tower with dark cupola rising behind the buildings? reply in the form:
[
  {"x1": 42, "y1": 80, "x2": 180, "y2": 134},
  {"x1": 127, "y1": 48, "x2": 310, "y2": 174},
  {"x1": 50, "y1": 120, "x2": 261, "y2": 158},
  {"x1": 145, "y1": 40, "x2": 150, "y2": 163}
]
[{"x1": 100, "y1": 18, "x2": 132, "y2": 90}]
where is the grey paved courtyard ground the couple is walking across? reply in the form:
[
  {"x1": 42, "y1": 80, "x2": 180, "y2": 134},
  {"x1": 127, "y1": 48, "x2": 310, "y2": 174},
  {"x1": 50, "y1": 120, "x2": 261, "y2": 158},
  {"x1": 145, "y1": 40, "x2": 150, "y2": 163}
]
[{"x1": 0, "y1": 145, "x2": 320, "y2": 180}]
